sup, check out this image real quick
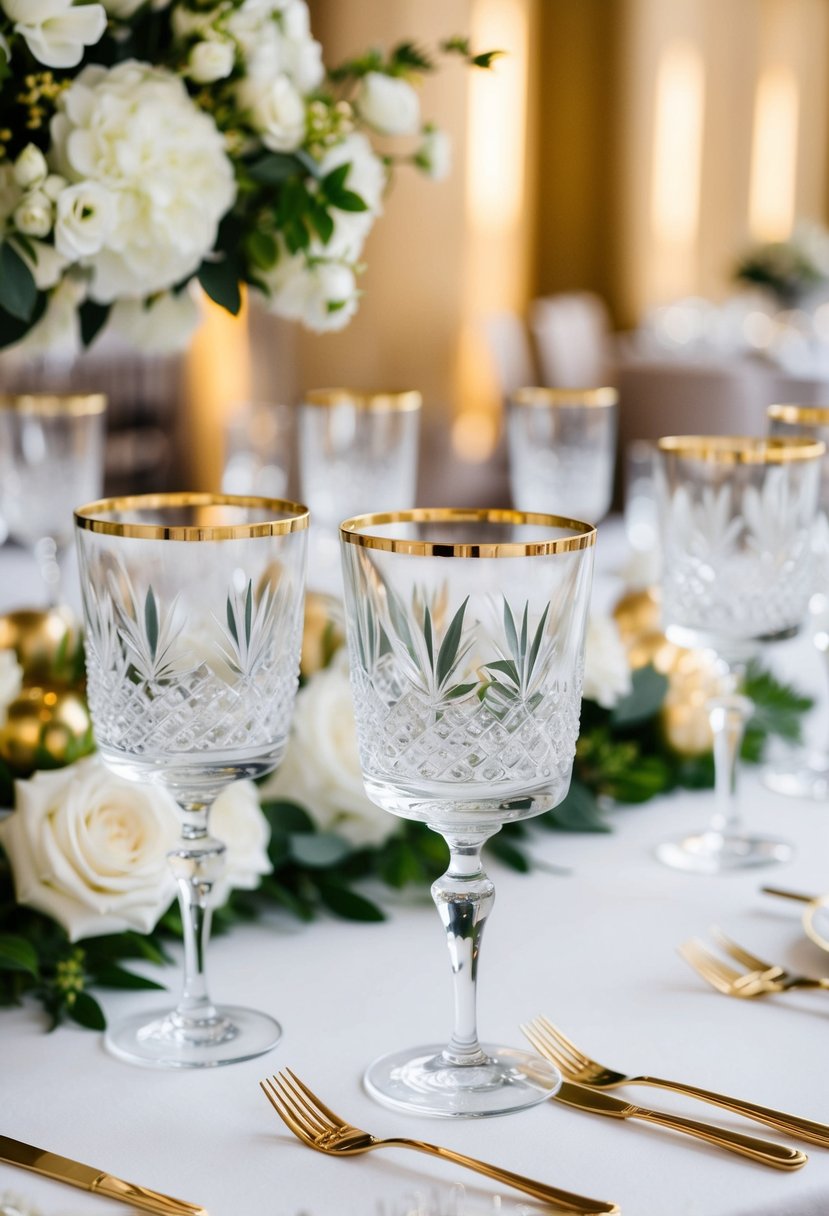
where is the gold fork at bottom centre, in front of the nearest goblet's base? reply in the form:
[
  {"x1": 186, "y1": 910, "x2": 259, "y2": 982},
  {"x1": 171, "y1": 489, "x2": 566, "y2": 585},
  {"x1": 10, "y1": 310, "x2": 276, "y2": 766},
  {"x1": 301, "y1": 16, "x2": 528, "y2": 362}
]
[{"x1": 259, "y1": 1069, "x2": 619, "y2": 1216}]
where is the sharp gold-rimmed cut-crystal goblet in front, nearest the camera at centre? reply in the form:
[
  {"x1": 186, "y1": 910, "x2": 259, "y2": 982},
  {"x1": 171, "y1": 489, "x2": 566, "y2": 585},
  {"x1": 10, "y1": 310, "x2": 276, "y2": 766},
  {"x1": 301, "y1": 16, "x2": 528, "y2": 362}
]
[{"x1": 340, "y1": 508, "x2": 596, "y2": 1115}]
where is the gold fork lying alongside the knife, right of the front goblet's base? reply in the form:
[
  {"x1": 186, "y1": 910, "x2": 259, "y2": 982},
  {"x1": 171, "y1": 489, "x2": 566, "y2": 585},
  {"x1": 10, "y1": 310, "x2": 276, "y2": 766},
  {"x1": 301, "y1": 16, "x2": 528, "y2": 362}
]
[{"x1": 521, "y1": 1018, "x2": 829, "y2": 1148}]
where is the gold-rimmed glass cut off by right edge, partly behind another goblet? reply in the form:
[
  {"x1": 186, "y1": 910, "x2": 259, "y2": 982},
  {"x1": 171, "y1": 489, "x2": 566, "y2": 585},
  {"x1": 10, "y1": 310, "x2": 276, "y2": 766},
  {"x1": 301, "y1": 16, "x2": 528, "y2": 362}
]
[{"x1": 763, "y1": 405, "x2": 829, "y2": 799}]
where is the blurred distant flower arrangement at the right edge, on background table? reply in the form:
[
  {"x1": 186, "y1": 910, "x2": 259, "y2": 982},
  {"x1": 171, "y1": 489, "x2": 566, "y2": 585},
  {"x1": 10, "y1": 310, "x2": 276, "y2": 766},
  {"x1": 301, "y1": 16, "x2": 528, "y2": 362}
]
[{"x1": 734, "y1": 221, "x2": 829, "y2": 308}]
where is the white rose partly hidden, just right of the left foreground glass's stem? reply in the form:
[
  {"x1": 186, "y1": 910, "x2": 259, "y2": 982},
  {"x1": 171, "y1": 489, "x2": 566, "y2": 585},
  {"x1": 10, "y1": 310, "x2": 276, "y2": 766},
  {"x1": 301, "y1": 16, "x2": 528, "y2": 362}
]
[{"x1": 210, "y1": 781, "x2": 273, "y2": 907}]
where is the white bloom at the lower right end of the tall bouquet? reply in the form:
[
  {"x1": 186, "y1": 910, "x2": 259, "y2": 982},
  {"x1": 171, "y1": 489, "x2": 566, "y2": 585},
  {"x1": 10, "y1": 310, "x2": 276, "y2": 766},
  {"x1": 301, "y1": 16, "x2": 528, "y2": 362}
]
[{"x1": 261, "y1": 250, "x2": 360, "y2": 333}]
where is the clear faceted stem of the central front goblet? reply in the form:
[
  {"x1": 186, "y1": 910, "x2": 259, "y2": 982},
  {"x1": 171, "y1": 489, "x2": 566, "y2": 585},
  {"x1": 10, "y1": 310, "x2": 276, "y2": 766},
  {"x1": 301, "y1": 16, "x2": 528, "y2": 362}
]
[{"x1": 432, "y1": 834, "x2": 495, "y2": 1064}]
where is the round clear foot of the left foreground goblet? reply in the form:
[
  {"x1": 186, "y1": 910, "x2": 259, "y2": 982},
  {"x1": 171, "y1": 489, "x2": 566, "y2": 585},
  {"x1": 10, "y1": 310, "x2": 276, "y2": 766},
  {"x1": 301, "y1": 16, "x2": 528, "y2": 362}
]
[{"x1": 105, "y1": 1006, "x2": 282, "y2": 1068}]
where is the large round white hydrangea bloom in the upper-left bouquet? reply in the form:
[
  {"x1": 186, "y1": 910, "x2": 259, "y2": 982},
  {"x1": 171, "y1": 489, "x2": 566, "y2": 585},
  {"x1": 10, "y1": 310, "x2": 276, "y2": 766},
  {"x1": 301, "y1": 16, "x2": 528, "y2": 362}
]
[{"x1": 51, "y1": 60, "x2": 236, "y2": 304}]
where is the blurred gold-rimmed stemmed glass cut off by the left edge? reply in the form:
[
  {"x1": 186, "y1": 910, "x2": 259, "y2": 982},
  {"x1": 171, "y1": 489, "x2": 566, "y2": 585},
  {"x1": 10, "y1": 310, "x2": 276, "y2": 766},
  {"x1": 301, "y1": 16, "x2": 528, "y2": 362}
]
[{"x1": 0, "y1": 393, "x2": 107, "y2": 608}]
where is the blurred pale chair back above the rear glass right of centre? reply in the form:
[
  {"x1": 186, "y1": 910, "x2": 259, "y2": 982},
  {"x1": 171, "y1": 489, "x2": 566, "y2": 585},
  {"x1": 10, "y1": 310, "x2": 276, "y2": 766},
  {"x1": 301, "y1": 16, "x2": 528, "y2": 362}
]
[{"x1": 530, "y1": 292, "x2": 615, "y2": 388}]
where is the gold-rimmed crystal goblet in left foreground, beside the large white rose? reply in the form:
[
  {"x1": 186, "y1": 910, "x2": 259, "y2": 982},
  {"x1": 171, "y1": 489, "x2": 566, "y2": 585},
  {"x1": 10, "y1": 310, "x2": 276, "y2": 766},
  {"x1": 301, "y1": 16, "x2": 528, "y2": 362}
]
[{"x1": 75, "y1": 494, "x2": 308, "y2": 1068}]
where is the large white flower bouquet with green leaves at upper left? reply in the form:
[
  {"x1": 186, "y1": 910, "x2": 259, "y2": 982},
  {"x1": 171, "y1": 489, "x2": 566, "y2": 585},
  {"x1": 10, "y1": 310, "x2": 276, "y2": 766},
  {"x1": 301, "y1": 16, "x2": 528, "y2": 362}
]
[{"x1": 0, "y1": 0, "x2": 496, "y2": 349}]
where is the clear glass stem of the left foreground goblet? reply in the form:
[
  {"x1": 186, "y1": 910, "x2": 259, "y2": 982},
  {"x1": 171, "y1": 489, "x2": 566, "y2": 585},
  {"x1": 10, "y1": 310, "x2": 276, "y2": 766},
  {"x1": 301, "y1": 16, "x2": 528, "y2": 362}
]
[{"x1": 169, "y1": 803, "x2": 225, "y2": 1024}]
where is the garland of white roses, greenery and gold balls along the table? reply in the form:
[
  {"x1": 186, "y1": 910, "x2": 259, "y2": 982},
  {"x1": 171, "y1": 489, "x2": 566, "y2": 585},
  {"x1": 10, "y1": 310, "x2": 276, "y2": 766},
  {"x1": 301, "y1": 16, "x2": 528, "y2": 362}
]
[{"x1": 0, "y1": 592, "x2": 811, "y2": 1029}]
